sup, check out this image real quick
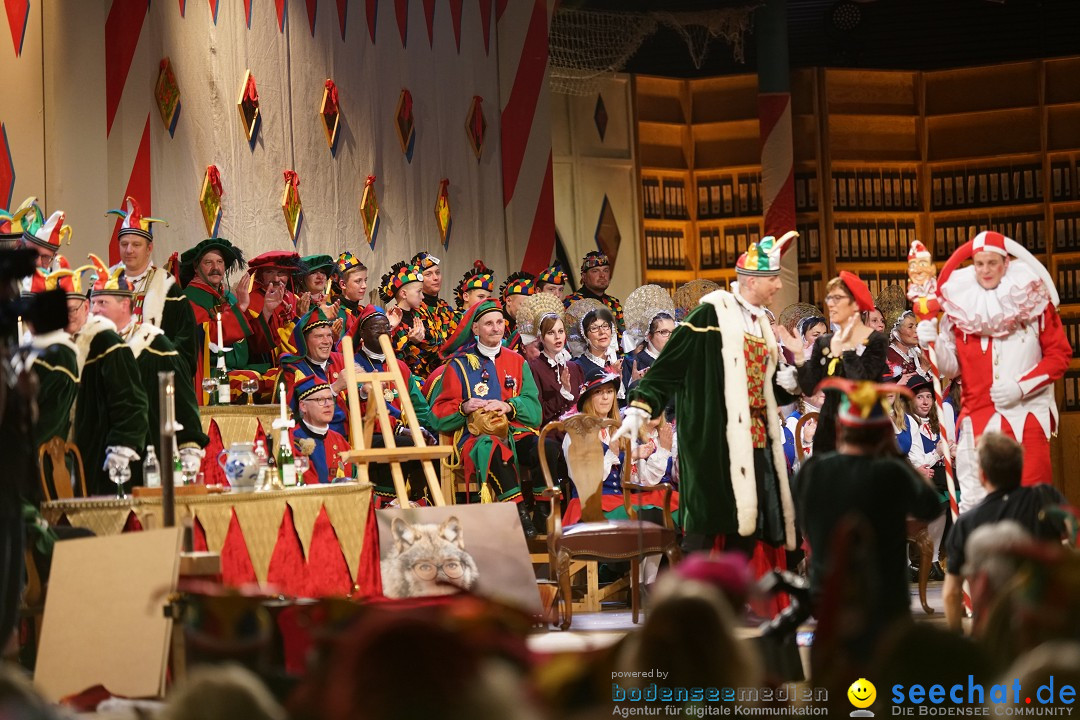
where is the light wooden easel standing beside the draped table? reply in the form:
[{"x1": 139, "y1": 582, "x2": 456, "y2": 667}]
[{"x1": 341, "y1": 335, "x2": 454, "y2": 507}]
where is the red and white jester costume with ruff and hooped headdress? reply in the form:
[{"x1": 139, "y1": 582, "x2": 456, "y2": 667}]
[{"x1": 935, "y1": 232, "x2": 1072, "y2": 513}]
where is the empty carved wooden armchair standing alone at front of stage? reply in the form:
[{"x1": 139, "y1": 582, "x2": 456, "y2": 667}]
[{"x1": 540, "y1": 413, "x2": 681, "y2": 630}]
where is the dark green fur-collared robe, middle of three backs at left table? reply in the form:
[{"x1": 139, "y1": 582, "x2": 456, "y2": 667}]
[{"x1": 75, "y1": 315, "x2": 147, "y2": 494}]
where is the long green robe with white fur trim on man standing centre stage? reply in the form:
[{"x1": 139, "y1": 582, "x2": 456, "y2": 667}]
[{"x1": 630, "y1": 290, "x2": 795, "y2": 548}]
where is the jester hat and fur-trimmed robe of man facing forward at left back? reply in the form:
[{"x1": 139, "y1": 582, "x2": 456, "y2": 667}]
[{"x1": 106, "y1": 196, "x2": 197, "y2": 377}]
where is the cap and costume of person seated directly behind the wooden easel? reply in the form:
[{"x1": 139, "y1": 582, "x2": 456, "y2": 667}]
[{"x1": 353, "y1": 305, "x2": 438, "y2": 507}]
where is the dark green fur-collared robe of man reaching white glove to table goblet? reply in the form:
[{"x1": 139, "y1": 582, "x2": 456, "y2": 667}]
[{"x1": 127, "y1": 324, "x2": 210, "y2": 485}]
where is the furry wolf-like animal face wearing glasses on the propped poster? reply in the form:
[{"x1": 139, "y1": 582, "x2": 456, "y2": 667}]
[{"x1": 381, "y1": 517, "x2": 480, "y2": 598}]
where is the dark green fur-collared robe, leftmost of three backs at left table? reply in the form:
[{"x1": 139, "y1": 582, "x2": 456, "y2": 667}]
[{"x1": 32, "y1": 330, "x2": 79, "y2": 450}]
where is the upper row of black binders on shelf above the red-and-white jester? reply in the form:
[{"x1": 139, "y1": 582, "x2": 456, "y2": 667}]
[{"x1": 930, "y1": 164, "x2": 1042, "y2": 210}]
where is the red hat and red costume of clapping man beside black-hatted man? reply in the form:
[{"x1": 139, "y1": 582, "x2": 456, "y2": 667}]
[{"x1": 247, "y1": 250, "x2": 307, "y2": 370}]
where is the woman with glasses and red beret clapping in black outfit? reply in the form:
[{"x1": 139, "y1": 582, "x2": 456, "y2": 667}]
[{"x1": 780, "y1": 270, "x2": 889, "y2": 454}]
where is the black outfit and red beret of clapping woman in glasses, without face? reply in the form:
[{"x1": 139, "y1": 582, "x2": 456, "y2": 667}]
[{"x1": 798, "y1": 270, "x2": 889, "y2": 453}]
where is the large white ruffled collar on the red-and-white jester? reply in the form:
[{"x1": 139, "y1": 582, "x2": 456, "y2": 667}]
[{"x1": 939, "y1": 261, "x2": 1050, "y2": 338}]
